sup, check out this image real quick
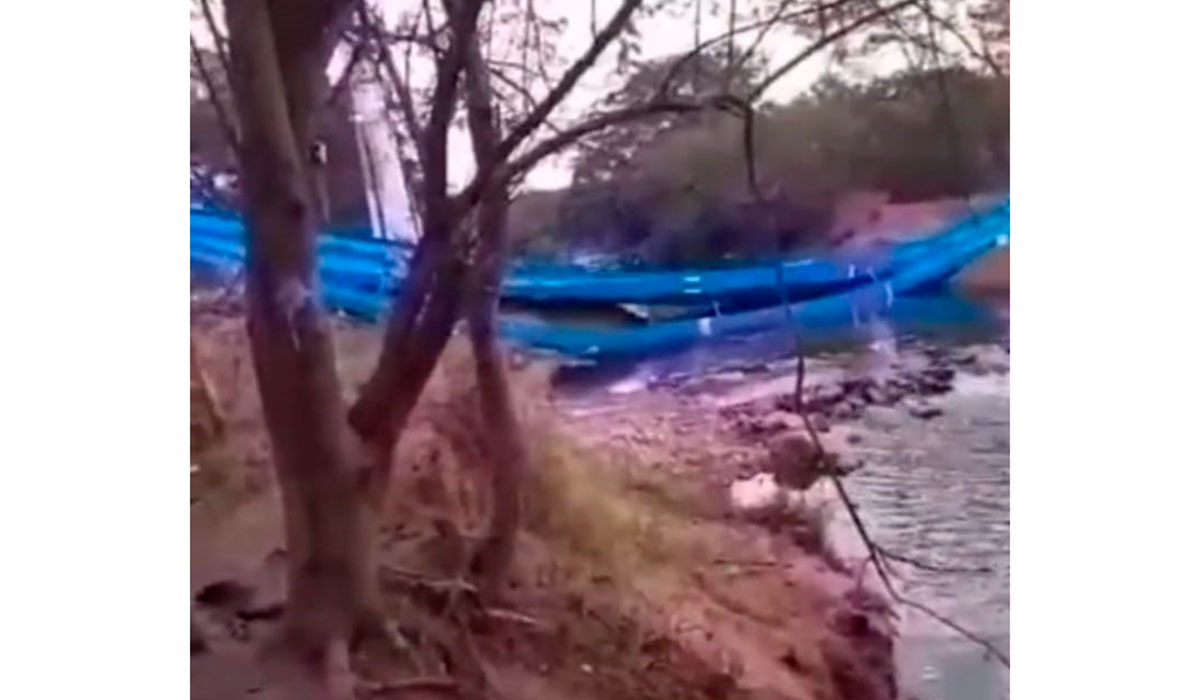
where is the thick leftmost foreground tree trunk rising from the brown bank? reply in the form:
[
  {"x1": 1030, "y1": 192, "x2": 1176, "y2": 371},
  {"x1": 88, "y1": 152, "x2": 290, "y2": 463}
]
[{"x1": 227, "y1": 0, "x2": 378, "y2": 694}]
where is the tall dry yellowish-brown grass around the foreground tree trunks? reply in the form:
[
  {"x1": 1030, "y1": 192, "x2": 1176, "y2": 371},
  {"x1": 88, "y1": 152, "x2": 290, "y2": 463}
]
[{"x1": 192, "y1": 318, "x2": 835, "y2": 590}]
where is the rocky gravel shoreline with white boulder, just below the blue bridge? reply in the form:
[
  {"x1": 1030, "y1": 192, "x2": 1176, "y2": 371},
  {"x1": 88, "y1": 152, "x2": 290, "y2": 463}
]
[{"x1": 556, "y1": 340, "x2": 1009, "y2": 549}]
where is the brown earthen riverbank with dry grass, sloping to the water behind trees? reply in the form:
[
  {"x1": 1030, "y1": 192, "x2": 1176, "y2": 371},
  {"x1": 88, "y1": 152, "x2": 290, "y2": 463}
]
[{"x1": 191, "y1": 312, "x2": 896, "y2": 700}]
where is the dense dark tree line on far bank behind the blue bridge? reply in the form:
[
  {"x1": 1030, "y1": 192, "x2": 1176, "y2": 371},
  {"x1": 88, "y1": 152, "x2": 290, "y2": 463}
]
[{"x1": 512, "y1": 53, "x2": 1009, "y2": 265}]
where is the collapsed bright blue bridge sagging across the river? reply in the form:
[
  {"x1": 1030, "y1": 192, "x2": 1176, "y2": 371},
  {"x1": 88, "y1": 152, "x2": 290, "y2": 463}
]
[{"x1": 191, "y1": 201, "x2": 1009, "y2": 361}]
